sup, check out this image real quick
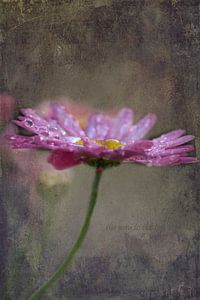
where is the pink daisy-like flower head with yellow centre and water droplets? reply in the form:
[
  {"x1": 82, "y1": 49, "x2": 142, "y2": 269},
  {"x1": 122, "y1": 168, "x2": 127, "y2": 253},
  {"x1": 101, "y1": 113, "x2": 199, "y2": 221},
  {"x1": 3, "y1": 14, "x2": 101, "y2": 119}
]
[{"x1": 9, "y1": 104, "x2": 198, "y2": 170}]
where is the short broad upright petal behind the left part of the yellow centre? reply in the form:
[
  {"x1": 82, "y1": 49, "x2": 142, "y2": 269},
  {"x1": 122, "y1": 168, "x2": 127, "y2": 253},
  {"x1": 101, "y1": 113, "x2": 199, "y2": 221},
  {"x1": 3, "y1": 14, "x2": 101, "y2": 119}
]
[{"x1": 86, "y1": 113, "x2": 112, "y2": 140}]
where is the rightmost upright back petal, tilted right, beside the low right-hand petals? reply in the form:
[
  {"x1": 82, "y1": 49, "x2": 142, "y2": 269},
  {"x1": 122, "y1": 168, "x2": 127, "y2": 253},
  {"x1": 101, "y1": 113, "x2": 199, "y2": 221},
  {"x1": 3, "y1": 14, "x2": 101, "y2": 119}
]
[{"x1": 126, "y1": 114, "x2": 157, "y2": 142}]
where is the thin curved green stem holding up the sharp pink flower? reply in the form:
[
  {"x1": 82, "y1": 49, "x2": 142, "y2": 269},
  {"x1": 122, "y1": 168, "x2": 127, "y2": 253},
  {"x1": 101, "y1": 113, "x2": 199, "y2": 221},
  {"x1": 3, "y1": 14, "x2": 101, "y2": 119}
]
[{"x1": 29, "y1": 169, "x2": 102, "y2": 300}]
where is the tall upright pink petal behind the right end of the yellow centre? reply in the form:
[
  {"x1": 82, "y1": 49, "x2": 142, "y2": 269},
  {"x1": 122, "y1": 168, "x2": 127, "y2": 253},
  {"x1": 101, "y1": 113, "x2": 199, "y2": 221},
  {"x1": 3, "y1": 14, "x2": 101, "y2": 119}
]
[{"x1": 109, "y1": 108, "x2": 133, "y2": 141}]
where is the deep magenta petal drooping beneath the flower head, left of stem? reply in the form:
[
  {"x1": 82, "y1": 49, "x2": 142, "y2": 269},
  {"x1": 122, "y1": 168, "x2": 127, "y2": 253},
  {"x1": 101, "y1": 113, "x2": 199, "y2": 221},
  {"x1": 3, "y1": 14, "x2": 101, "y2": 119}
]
[{"x1": 48, "y1": 150, "x2": 81, "y2": 170}]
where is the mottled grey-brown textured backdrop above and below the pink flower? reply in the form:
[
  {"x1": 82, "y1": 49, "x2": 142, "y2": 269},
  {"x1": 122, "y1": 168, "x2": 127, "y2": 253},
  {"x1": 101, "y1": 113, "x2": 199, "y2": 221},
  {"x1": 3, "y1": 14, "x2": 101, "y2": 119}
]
[{"x1": 0, "y1": 0, "x2": 200, "y2": 300}]
